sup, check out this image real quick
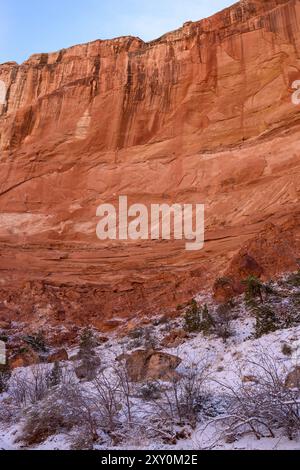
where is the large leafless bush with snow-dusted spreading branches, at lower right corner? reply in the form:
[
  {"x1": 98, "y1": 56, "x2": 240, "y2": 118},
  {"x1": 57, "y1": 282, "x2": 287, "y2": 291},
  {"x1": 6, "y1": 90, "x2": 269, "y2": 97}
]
[{"x1": 211, "y1": 350, "x2": 300, "y2": 440}]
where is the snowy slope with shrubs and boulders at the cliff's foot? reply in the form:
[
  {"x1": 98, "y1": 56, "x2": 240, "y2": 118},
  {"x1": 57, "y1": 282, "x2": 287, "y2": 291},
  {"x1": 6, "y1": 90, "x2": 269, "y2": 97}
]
[{"x1": 0, "y1": 274, "x2": 300, "y2": 449}]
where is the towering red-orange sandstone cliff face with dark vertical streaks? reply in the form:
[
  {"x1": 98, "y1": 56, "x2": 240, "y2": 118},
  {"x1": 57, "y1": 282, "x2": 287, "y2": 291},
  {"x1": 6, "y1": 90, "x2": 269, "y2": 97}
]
[{"x1": 0, "y1": 0, "x2": 300, "y2": 327}]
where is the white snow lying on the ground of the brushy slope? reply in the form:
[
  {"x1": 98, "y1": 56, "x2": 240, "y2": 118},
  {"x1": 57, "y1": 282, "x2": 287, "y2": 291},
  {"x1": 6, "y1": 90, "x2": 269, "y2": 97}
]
[{"x1": 0, "y1": 276, "x2": 300, "y2": 450}]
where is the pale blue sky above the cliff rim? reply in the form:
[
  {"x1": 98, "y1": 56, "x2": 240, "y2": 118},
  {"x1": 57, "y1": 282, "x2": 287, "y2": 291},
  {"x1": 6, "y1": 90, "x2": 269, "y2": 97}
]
[{"x1": 0, "y1": 0, "x2": 234, "y2": 63}]
